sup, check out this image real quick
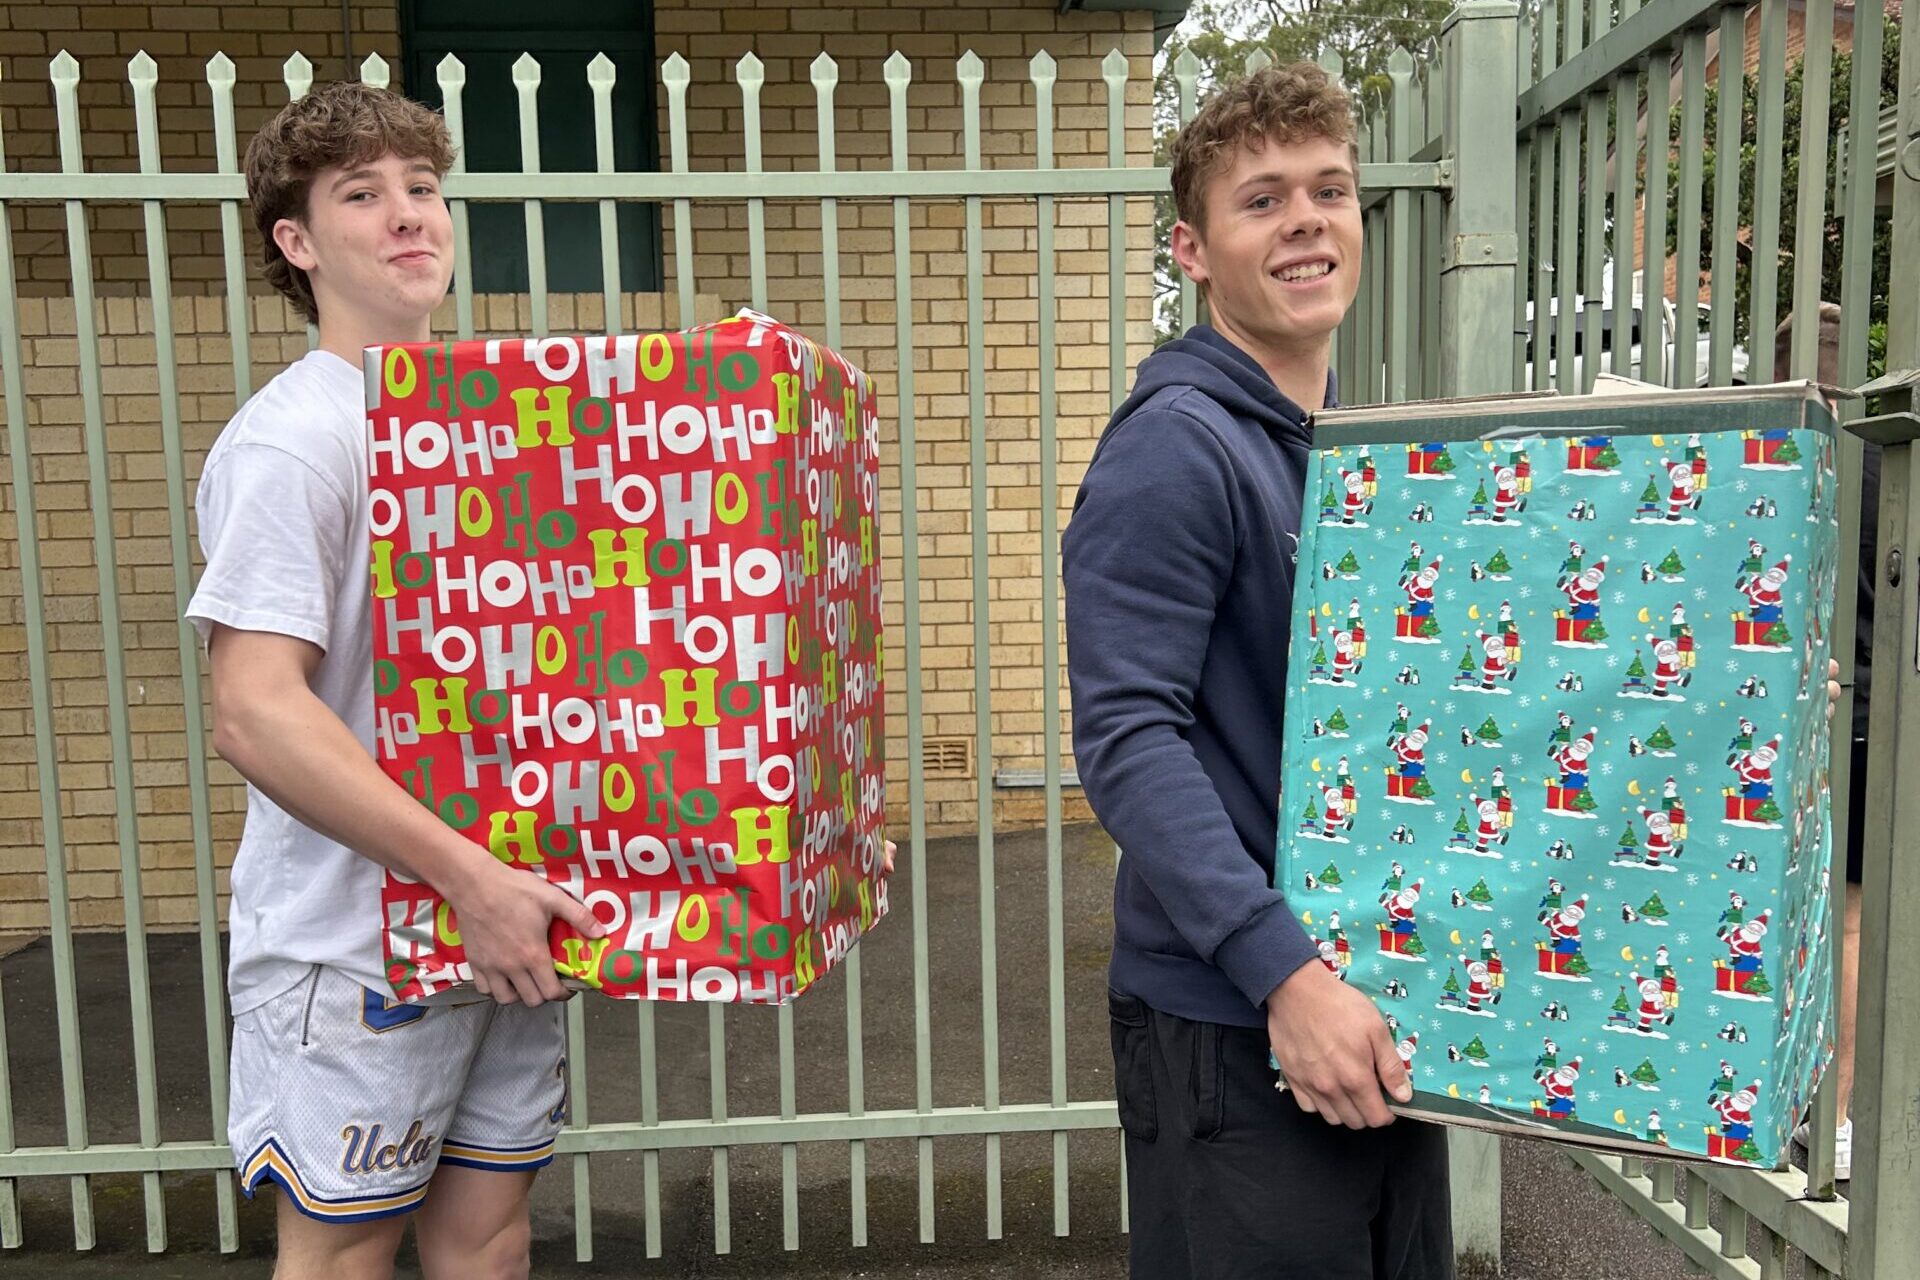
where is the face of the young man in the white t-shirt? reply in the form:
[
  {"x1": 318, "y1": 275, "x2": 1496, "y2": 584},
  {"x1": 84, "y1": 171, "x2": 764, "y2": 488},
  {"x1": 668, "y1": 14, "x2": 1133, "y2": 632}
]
[{"x1": 273, "y1": 154, "x2": 453, "y2": 342}]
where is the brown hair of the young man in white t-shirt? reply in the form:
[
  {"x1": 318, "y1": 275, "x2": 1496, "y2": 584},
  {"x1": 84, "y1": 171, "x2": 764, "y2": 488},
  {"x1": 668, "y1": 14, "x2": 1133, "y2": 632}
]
[{"x1": 246, "y1": 81, "x2": 453, "y2": 324}]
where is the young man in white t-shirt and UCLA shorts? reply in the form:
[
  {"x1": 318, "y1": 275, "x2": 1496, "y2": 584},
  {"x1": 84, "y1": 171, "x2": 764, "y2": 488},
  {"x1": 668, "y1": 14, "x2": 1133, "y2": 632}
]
[{"x1": 188, "y1": 84, "x2": 605, "y2": 1280}]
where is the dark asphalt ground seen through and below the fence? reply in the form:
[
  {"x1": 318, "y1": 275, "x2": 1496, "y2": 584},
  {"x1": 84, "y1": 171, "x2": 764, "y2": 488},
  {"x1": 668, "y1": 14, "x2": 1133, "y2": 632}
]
[{"x1": 0, "y1": 827, "x2": 1789, "y2": 1280}]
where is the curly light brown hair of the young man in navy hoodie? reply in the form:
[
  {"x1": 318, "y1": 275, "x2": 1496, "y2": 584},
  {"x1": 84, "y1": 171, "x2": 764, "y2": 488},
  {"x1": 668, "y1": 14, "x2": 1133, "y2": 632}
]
[{"x1": 1173, "y1": 61, "x2": 1359, "y2": 236}]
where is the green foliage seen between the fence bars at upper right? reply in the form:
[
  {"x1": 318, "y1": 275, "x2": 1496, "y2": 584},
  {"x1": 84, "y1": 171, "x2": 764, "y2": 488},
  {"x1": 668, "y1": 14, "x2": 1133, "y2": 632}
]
[{"x1": 1642, "y1": 23, "x2": 1901, "y2": 378}]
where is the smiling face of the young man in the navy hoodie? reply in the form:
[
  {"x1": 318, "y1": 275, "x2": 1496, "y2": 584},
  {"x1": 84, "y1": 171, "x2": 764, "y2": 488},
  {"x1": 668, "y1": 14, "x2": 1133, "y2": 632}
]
[{"x1": 1173, "y1": 138, "x2": 1361, "y2": 364}]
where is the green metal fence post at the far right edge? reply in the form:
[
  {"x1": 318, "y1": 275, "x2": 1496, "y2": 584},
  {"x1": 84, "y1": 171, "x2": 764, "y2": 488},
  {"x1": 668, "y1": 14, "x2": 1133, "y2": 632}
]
[{"x1": 1847, "y1": 6, "x2": 1920, "y2": 1278}]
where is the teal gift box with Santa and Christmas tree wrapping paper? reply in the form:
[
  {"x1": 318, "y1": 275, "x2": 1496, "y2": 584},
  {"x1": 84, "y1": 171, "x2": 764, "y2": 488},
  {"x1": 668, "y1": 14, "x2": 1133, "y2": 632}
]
[{"x1": 1275, "y1": 384, "x2": 1839, "y2": 1169}]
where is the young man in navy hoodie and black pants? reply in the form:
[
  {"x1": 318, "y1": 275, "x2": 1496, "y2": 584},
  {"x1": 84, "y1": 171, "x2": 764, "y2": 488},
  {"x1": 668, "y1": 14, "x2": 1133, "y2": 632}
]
[{"x1": 1064, "y1": 63, "x2": 1453, "y2": 1280}]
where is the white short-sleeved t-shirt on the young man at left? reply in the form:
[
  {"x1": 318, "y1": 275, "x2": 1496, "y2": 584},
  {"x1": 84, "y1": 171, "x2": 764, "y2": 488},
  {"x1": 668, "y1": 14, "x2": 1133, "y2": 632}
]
[{"x1": 186, "y1": 351, "x2": 386, "y2": 1015}]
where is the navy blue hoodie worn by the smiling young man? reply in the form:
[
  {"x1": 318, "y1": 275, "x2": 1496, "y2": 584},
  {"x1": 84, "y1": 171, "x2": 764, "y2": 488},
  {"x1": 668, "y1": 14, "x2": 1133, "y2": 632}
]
[{"x1": 1062, "y1": 326, "x2": 1331, "y2": 1027}]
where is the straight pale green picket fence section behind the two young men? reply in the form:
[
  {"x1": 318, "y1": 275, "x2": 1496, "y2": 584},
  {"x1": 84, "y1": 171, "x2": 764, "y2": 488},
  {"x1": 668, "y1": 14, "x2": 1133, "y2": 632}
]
[{"x1": 0, "y1": 27, "x2": 1466, "y2": 1257}]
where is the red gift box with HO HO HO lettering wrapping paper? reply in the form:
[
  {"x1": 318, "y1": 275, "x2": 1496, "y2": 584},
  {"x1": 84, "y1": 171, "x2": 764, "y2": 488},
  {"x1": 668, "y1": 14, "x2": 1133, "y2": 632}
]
[{"x1": 365, "y1": 313, "x2": 887, "y2": 1004}]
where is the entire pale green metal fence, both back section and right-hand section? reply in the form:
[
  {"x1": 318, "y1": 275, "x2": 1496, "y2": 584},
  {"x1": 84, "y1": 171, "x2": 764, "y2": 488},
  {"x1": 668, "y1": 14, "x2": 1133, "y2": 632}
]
[{"x1": 0, "y1": 0, "x2": 1920, "y2": 1276}]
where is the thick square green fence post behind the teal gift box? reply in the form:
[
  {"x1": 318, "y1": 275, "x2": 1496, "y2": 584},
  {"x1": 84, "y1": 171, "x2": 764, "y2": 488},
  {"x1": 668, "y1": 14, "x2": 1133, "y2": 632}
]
[{"x1": 1438, "y1": 0, "x2": 1521, "y2": 1274}]
